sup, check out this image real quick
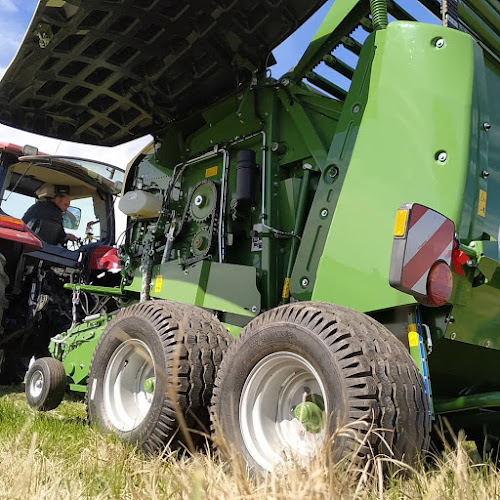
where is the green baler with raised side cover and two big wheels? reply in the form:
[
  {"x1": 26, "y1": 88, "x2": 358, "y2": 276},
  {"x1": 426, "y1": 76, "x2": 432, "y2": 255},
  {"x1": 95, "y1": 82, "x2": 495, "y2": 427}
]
[{"x1": 0, "y1": 0, "x2": 500, "y2": 470}]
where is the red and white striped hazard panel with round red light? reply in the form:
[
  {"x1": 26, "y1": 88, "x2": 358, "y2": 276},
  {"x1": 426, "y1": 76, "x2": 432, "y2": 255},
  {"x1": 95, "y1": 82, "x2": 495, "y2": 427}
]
[{"x1": 389, "y1": 203, "x2": 455, "y2": 306}]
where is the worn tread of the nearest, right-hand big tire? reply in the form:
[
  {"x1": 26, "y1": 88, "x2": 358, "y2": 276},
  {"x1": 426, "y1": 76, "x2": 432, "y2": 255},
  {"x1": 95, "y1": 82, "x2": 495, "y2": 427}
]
[{"x1": 211, "y1": 302, "x2": 431, "y2": 462}]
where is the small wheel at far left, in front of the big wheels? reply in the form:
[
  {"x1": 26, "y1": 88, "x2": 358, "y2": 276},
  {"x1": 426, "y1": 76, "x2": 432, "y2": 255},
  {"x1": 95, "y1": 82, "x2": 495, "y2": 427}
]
[{"x1": 25, "y1": 358, "x2": 67, "y2": 411}]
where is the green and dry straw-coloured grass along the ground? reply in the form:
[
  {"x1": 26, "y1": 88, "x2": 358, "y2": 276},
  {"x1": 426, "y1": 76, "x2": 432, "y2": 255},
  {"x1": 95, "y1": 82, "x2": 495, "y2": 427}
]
[{"x1": 0, "y1": 387, "x2": 500, "y2": 500}]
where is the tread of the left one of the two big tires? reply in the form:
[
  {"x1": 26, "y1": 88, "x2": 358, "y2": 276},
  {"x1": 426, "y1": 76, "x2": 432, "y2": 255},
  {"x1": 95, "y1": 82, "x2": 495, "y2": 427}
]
[{"x1": 87, "y1": 300, "x2": 231, "y2": 453}]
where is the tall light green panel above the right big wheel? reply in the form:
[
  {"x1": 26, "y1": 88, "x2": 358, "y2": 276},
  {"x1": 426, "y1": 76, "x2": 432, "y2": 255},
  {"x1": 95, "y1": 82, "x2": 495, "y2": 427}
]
[{"x1": 312, "y1": 22, "x2": 474, "y2": 311}]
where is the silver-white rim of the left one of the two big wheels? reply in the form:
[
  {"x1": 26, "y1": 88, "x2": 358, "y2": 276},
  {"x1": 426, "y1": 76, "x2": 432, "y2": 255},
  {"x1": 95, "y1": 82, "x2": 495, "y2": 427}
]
[{"x1": 103, "y1": 339, "x2": 155, "y2": 432}]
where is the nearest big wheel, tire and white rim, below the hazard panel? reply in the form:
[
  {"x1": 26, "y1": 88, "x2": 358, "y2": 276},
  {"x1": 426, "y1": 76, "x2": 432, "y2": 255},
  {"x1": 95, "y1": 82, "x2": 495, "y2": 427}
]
[{"x1": 211, "y1": 302, "x2": 431, "y2": 472}]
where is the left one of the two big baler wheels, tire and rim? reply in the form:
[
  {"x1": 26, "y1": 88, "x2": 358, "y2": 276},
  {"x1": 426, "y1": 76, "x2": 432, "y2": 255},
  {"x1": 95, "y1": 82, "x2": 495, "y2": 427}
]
[{"x1": 87, "y1": 301, "x2": 230, "y2": 453}]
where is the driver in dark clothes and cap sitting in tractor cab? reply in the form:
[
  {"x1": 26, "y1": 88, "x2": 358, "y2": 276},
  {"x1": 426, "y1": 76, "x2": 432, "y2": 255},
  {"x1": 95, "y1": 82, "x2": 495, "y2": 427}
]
[{"x1": 23, "y1": 191, "x2": 77, "y2": 245}]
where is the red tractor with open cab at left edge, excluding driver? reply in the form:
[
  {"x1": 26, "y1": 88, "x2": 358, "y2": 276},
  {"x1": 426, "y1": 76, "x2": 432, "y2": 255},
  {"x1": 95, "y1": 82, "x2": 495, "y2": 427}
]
[{"x1": 0, "y1": 143, "x2": 124, "y2": 384}]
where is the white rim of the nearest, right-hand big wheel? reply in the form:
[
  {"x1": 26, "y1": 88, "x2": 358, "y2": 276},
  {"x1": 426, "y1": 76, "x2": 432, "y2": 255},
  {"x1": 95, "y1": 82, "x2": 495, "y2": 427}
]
[{"x1": 239, "y1": 351, "x2": 328, "y2": 470}]
